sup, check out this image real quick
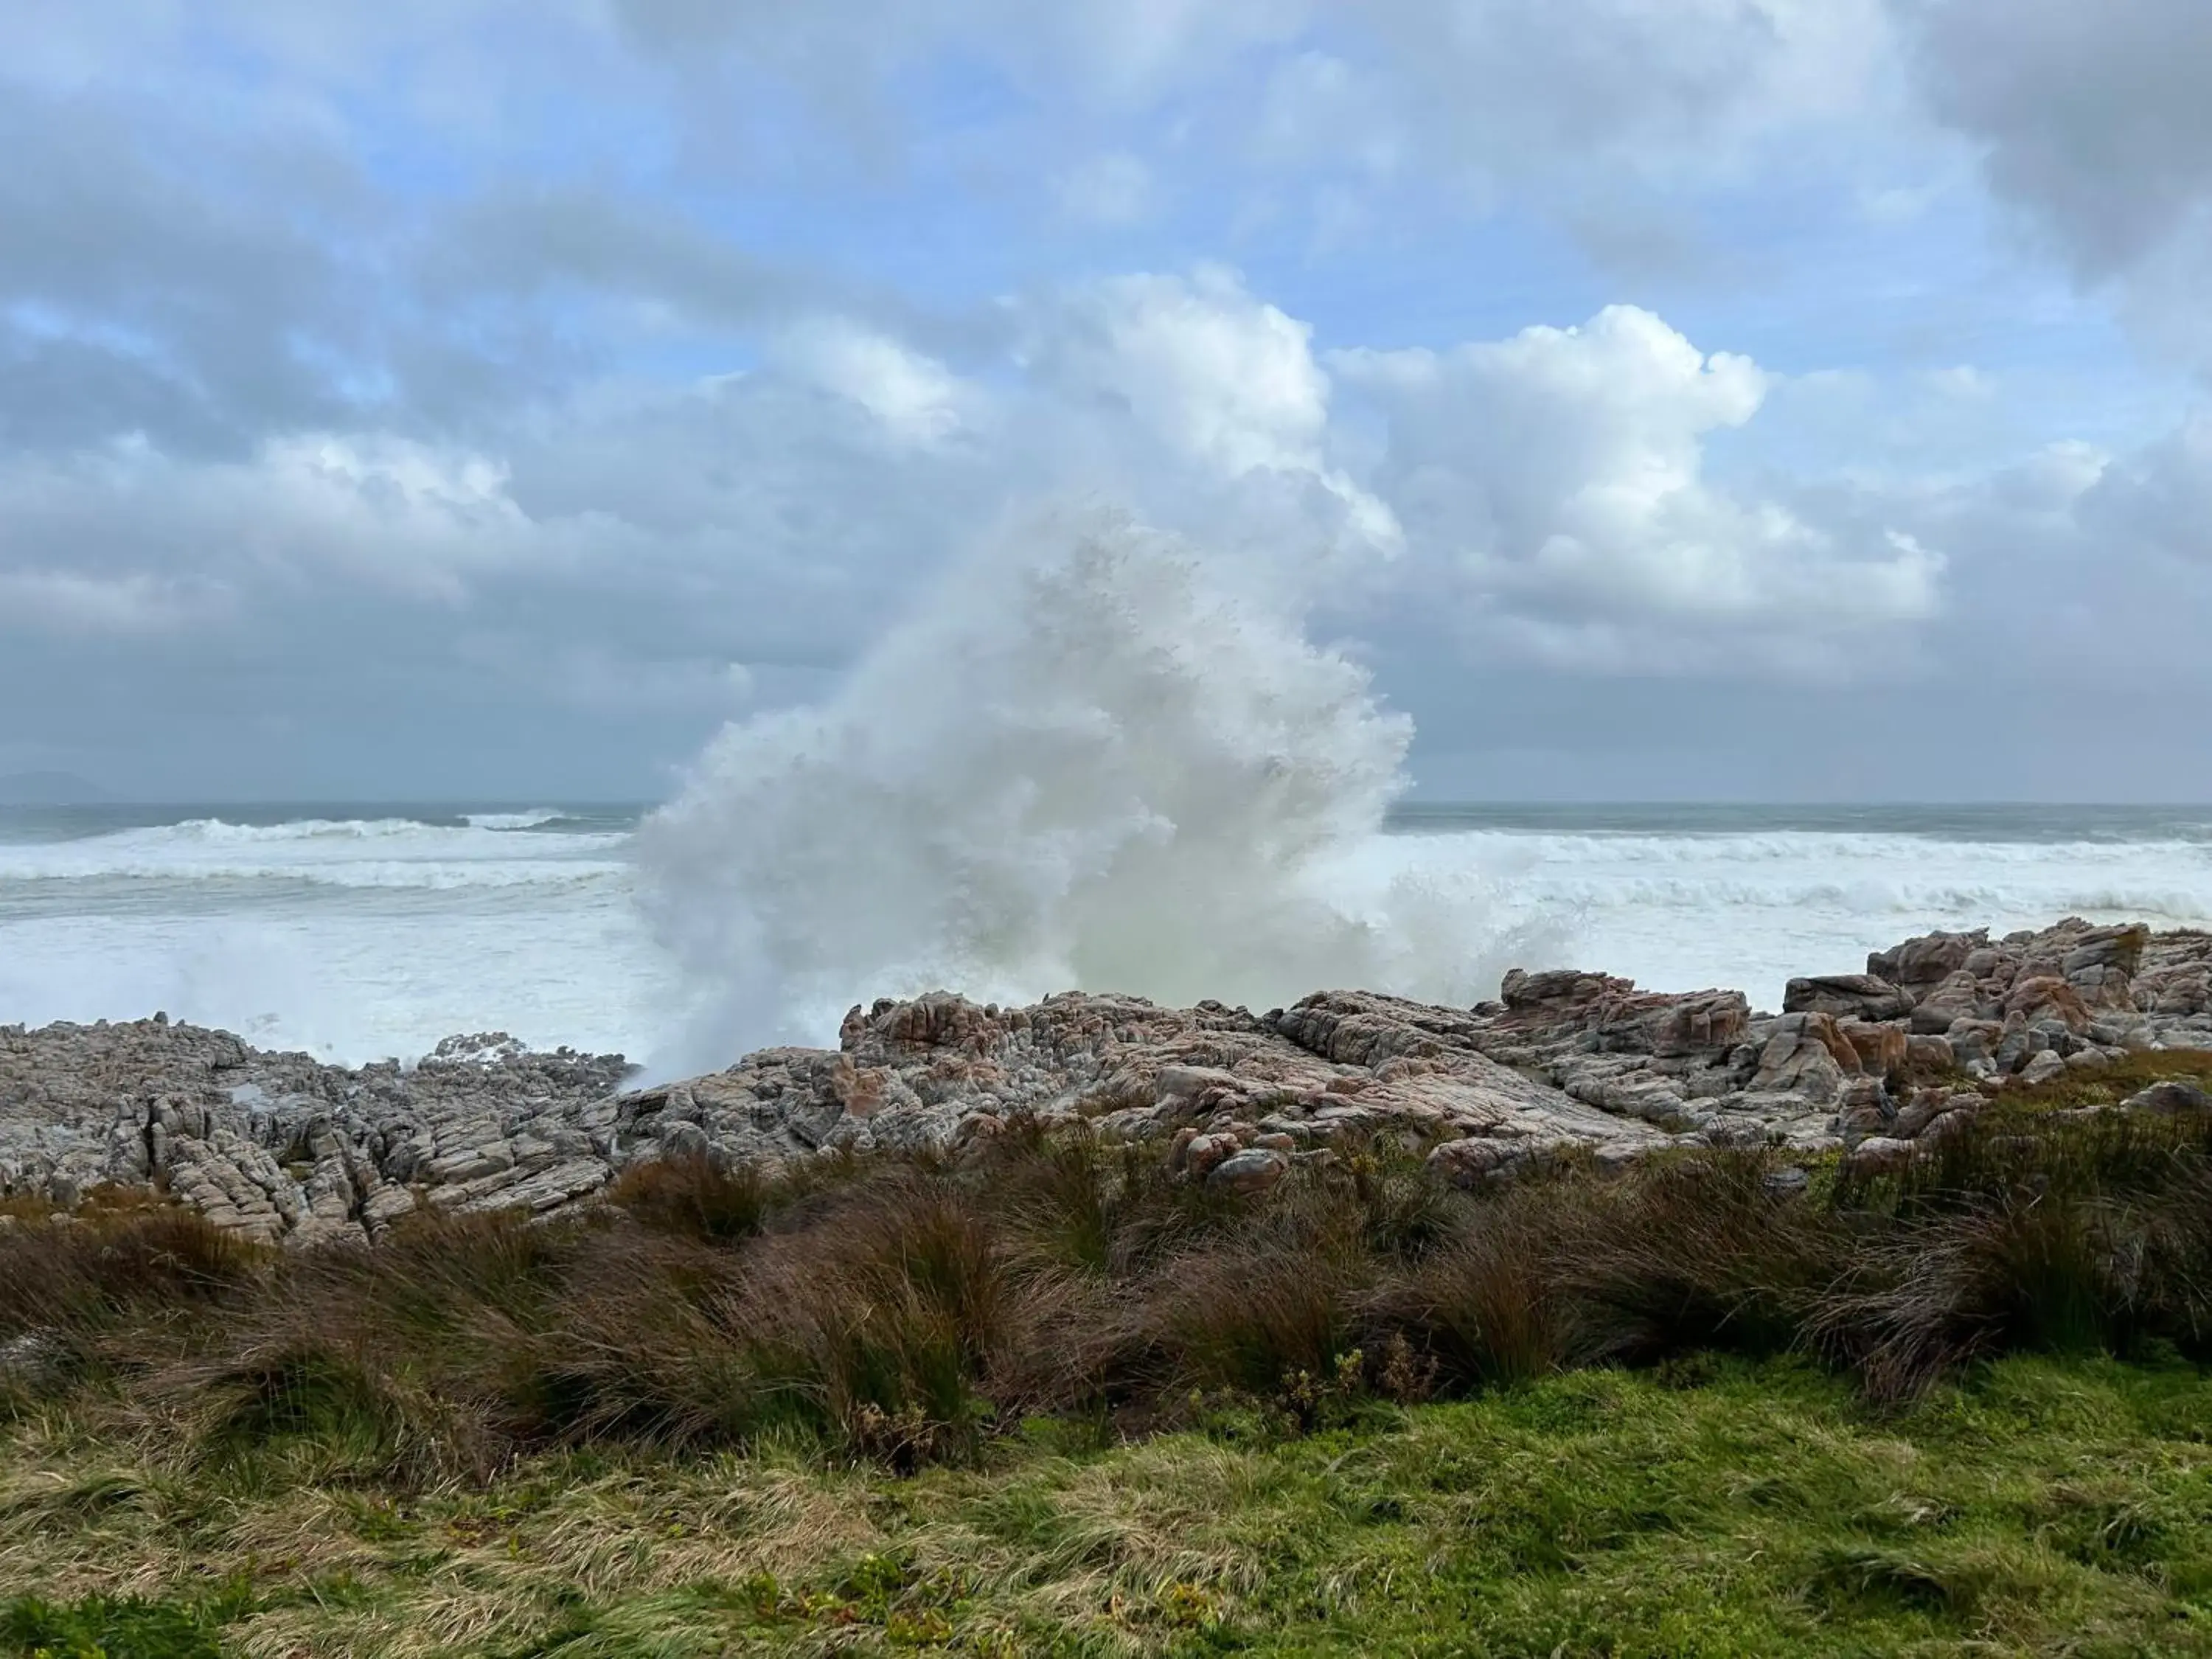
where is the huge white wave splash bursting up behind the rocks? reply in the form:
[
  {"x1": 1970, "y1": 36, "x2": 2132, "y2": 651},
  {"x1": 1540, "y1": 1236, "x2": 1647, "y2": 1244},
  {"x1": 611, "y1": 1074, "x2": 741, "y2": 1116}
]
[{"x1": 637, "y1": 513, "x2": 1540, "y2": 1064}]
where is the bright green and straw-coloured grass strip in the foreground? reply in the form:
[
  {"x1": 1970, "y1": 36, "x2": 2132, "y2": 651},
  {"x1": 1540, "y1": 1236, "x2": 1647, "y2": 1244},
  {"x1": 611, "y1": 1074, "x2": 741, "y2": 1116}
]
[{"x1": 0, "y1": 1356, "x2": 2212, "y2": 1659}]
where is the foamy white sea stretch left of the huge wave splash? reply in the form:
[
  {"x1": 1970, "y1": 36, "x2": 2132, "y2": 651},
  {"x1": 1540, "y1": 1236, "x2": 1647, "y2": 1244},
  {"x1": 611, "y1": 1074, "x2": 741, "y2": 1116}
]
[{"x1": 0, "y1": 810, "x2": 675, "y2": 1062}]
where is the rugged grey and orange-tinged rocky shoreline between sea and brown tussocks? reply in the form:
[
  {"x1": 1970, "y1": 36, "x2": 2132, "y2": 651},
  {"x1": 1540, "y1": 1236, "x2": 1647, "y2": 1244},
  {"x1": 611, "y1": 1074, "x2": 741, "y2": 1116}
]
[{"x1": 0, "y1": 920, "x2": 2212, "y2": 1243}]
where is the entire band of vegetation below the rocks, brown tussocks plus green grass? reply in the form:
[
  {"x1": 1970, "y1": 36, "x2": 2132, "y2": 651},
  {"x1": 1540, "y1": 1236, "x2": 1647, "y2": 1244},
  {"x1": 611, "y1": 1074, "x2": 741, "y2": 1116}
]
[{"x1": 13, "y1": 1084, "x2": 2212, "y2": 1659}]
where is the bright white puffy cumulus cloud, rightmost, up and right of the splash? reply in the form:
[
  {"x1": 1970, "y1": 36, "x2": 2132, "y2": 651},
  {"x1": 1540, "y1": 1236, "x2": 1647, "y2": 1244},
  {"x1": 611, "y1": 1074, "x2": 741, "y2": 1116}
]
[{"x1": 1332, "y1": 305, "x2": 1942, "y2": 672}]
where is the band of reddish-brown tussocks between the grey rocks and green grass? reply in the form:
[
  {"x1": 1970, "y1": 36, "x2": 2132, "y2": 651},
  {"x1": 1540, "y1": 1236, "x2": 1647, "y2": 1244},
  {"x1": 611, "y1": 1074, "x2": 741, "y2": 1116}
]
[{"x1": 30, "y1": 1102, "x2": 2212, "y2": 1482}]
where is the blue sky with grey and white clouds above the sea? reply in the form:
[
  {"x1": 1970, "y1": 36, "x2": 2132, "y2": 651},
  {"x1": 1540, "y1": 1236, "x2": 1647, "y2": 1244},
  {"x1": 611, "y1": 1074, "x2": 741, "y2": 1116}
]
[{"x1": 0, "y1": 0, "x2": 2212, "y2": 801}]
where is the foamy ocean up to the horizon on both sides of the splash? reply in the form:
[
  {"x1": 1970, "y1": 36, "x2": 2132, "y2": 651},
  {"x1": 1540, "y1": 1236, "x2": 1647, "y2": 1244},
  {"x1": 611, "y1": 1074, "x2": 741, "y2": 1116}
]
[{"x1": 0, "y1": 803, "x2": 2212, "y2": 1062}]
